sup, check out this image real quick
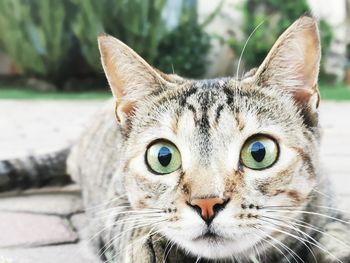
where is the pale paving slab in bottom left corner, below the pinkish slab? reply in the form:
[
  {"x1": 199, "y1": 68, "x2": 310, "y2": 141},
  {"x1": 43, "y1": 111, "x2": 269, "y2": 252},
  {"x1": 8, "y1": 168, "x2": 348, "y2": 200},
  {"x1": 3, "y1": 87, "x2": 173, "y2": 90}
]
[{"x1": 0, "y1": 244, "x2": 96, "y2": 263}]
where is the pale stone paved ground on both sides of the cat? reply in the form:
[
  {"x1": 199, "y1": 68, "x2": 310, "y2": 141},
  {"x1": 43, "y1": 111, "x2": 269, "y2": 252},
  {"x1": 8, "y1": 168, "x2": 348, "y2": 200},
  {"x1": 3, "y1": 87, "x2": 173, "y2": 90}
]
[{"x1": 0, "y1": 100, "x2": 350, "y2": 263}]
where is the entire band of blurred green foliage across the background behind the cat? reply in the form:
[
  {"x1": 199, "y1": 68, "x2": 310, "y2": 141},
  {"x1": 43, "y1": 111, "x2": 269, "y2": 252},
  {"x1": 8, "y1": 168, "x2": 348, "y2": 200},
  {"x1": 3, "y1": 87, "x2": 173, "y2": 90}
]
[{"x1": 0, "y1": 0, "x2": 350, "y2": 98}]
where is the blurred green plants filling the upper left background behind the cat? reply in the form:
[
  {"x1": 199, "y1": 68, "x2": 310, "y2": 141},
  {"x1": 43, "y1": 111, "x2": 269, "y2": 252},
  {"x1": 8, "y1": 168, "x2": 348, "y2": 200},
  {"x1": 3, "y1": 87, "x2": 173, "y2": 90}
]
[{"x1": 0, "y1": 0, "x2": 219, "y2": 85}]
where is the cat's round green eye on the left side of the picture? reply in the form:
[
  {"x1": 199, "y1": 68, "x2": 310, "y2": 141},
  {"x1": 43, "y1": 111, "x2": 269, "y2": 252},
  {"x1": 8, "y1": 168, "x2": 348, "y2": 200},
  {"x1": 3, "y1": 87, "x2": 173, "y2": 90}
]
[{"x1": 146, "y1": 140, "x2": 181, "y2": 174}]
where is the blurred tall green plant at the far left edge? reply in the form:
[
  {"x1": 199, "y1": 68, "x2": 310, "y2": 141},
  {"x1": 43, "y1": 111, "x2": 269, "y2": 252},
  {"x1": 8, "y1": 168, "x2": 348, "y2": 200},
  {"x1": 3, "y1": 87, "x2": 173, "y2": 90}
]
[{"x1": 0, "y1": 0, "x2": 69, "y2": 80}]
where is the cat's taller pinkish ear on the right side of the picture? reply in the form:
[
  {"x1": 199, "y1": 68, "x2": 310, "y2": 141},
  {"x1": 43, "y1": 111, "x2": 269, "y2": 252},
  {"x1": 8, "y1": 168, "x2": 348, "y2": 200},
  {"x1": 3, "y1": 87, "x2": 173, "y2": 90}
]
[{"x1": 255, "y1": 16, "x2": 321, "y2": 110}]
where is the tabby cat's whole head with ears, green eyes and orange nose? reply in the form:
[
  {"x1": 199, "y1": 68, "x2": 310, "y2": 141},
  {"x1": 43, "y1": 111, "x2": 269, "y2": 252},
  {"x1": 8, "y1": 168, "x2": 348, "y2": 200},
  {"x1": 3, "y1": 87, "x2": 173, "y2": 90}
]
[{"x1": 99, "y1": 16, "x2": 320, "y2": 258}]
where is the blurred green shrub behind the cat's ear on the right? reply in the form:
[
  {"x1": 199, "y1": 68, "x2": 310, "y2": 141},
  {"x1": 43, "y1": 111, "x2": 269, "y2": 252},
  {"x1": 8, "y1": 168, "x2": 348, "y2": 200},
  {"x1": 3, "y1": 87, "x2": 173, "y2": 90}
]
[{"x1": 228, "y1": 0, "x2": 333, "y2": 79}]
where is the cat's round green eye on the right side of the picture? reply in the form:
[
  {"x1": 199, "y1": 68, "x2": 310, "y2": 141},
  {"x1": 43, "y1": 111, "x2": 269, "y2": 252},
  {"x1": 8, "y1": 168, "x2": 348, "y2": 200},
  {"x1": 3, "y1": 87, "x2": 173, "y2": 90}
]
[{"x1": 241, "y1": 135, "x2": 278, "y2": 170}]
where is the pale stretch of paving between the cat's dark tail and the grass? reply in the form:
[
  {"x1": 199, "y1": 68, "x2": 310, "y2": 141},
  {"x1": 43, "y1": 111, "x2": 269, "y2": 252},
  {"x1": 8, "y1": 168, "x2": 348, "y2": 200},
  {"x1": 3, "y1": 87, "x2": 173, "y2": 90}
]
[{"x1": 0, "y1": 100, "x2": 105, "y2": 159}]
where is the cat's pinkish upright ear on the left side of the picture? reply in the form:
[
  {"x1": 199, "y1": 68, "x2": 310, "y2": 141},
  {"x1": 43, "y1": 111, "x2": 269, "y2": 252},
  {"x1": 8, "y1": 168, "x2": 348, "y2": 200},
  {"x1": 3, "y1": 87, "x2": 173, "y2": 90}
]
[{"x1": 98, "y1": 34, "x2": 169, "y2": 125}]
